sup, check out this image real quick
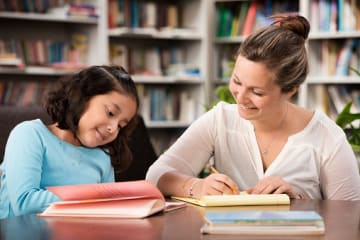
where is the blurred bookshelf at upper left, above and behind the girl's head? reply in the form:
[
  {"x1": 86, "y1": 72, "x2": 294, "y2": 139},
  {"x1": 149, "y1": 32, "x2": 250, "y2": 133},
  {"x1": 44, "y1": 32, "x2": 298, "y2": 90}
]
[{"x1": 0, "y1": 0, "x2": 107, "y2": 107}]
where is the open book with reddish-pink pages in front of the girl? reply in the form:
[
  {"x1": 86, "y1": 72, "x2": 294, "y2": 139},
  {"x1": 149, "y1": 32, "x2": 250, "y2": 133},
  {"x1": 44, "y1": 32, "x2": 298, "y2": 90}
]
[{"x1": 39, "y1": 180, "x2": 185, "y2": 218}]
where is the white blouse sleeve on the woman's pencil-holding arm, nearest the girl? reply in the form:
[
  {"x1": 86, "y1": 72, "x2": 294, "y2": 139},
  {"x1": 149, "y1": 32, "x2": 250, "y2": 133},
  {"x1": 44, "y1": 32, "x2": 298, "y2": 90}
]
[{"x1": 146, "y1": 109, "x2": 216, "y2": 185}]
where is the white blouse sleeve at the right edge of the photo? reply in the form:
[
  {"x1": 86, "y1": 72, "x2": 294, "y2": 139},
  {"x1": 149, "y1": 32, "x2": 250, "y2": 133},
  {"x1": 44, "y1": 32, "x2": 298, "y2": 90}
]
[{"x1": 320, "y1": 136, "x2": 360, "y2": 200}]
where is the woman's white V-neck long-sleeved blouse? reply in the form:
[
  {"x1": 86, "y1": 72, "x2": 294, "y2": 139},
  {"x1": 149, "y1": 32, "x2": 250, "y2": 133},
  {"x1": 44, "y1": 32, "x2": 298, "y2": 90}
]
[{"x1": 146, "y1": 102, "x2": 360, "y2": 200}]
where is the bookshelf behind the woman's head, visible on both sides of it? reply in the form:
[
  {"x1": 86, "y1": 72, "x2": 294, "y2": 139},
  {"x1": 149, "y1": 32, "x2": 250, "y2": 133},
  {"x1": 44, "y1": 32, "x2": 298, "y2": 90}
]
[{"x1": 209, "y1": 0, "x2": 360, "y2": 122}]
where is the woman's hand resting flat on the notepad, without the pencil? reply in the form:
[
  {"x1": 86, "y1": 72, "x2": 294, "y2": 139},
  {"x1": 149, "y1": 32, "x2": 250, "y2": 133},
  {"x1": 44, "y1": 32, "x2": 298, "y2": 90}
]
[{"x1": 246, "y1": 176, "x2": 303, "y2": 199}]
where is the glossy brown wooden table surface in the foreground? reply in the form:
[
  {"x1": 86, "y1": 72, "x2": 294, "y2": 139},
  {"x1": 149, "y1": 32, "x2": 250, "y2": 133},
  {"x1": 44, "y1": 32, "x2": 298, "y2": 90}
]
[{"x1": 0, "y1": 200, "x2": 360, "y2": 240}]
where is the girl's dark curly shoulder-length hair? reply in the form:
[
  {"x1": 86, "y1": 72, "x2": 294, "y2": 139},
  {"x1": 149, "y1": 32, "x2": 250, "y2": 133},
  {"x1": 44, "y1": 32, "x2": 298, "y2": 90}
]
[{"x1": 45, "y1": 66, "x2": 139, "y2": 172}]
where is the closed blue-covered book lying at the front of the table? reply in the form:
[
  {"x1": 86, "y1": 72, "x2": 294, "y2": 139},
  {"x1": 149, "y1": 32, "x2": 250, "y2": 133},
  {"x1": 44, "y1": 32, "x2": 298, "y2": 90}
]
[{"x1": 201, "y1": 211, "x2": 325, "y2": 236}]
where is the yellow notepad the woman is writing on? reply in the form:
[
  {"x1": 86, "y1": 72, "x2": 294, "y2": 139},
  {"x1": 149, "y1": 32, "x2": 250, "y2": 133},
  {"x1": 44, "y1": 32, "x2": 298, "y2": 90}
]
[{"x1": 172, "y1": 192, "x2": 290, "y2": 207}]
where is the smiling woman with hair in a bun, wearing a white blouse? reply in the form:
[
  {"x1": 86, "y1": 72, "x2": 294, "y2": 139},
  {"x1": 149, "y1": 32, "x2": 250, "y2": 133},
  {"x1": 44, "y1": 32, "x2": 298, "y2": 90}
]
[{"x1": 147, "y1": 16, "x2": 360, "y2": 200}]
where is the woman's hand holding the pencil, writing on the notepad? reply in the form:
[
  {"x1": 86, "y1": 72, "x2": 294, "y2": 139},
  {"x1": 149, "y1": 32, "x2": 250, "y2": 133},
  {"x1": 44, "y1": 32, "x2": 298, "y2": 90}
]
[{"x1": 193, "y1": 173, "x2": 239, "y2": 198}]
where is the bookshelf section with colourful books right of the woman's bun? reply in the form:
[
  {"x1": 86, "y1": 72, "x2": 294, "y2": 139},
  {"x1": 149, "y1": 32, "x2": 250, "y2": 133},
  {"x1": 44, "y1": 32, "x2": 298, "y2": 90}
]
[{"x1": 299, "y1": 0, "x2": 360, "y2": 119}]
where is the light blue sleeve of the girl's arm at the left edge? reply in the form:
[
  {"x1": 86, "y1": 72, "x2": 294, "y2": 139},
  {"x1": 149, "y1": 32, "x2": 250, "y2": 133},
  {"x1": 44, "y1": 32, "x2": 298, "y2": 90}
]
[{"x1": 4, "y1": 124, "x2": 60, "y2": 215}]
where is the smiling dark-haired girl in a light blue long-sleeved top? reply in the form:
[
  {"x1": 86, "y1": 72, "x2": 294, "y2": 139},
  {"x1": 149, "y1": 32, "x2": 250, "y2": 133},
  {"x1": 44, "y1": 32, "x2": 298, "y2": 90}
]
[{"x1": 0, "y1": 66, "x2": 139, "y2": 218}]
